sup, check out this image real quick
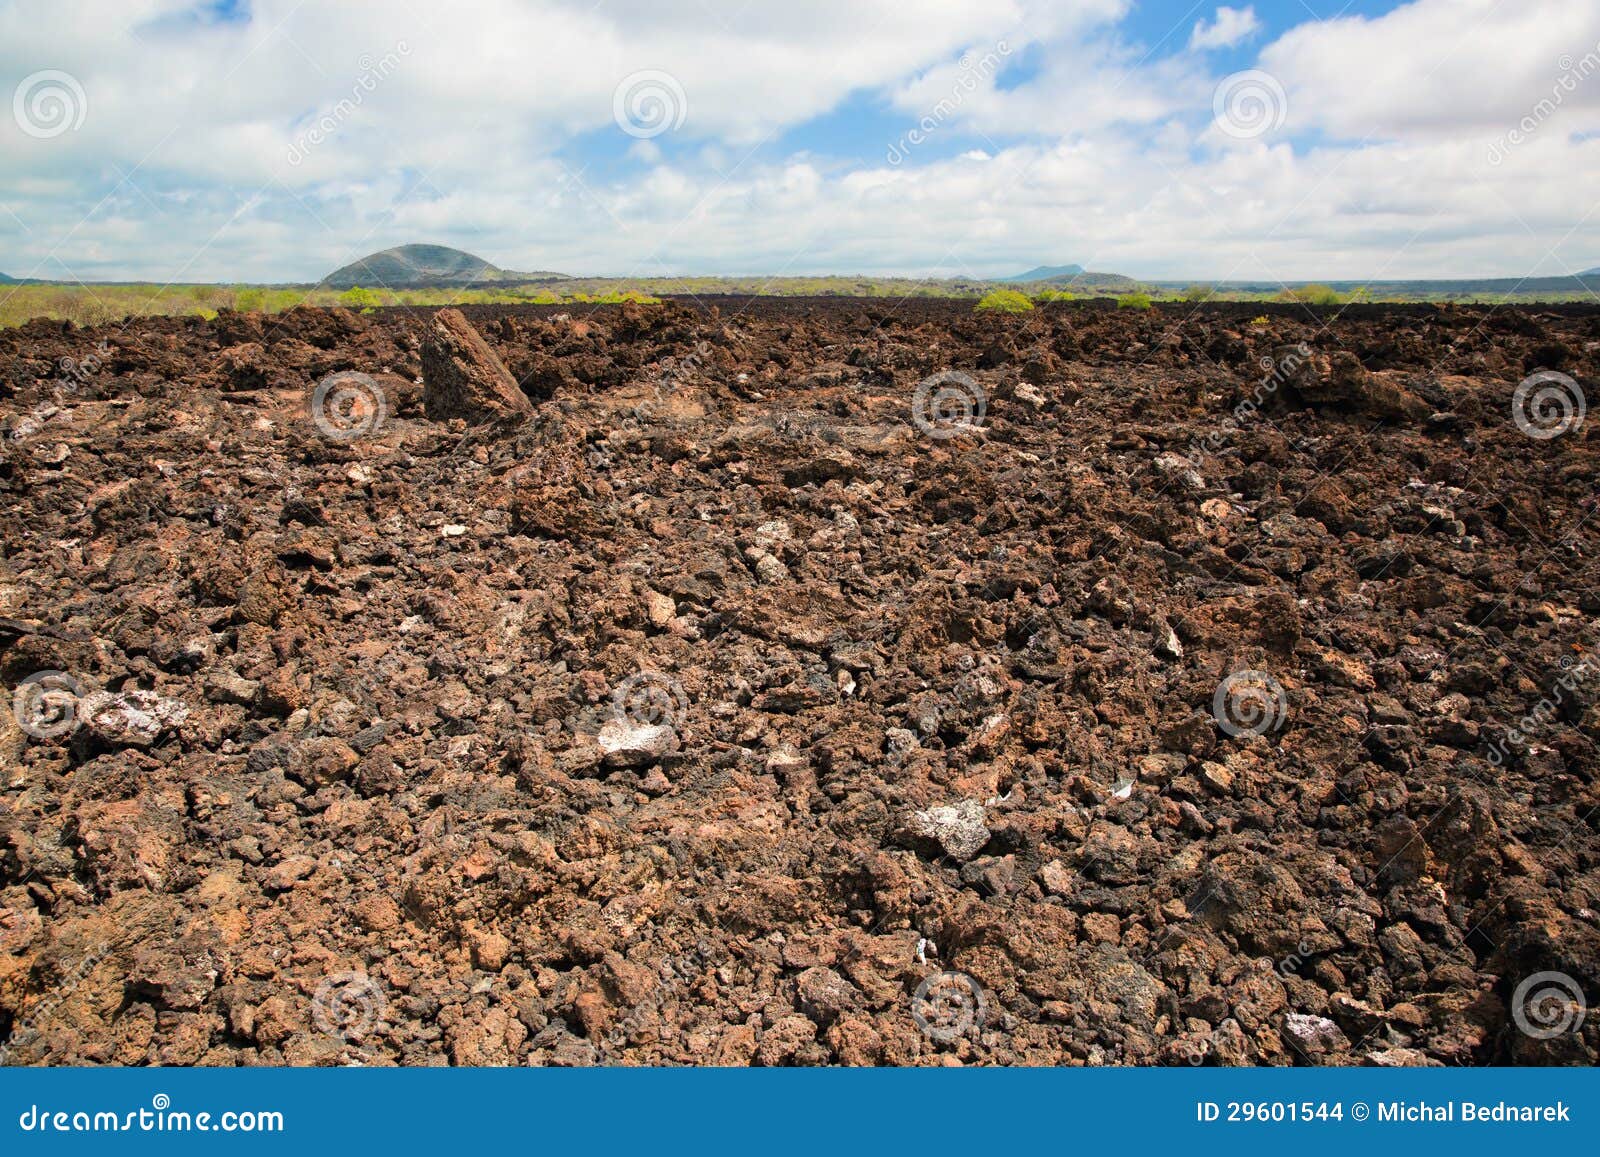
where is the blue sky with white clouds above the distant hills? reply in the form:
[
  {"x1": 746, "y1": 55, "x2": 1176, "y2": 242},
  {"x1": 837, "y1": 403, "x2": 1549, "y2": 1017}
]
[{"x1": 0, "y1": 0, "x2": 1600, "y2": 282}]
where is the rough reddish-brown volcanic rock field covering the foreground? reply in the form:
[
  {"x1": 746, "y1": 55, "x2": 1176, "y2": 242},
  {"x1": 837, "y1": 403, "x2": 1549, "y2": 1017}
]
[{"x1": 0, "y1": 299, "x2": 1600, "y2": 1066}]
